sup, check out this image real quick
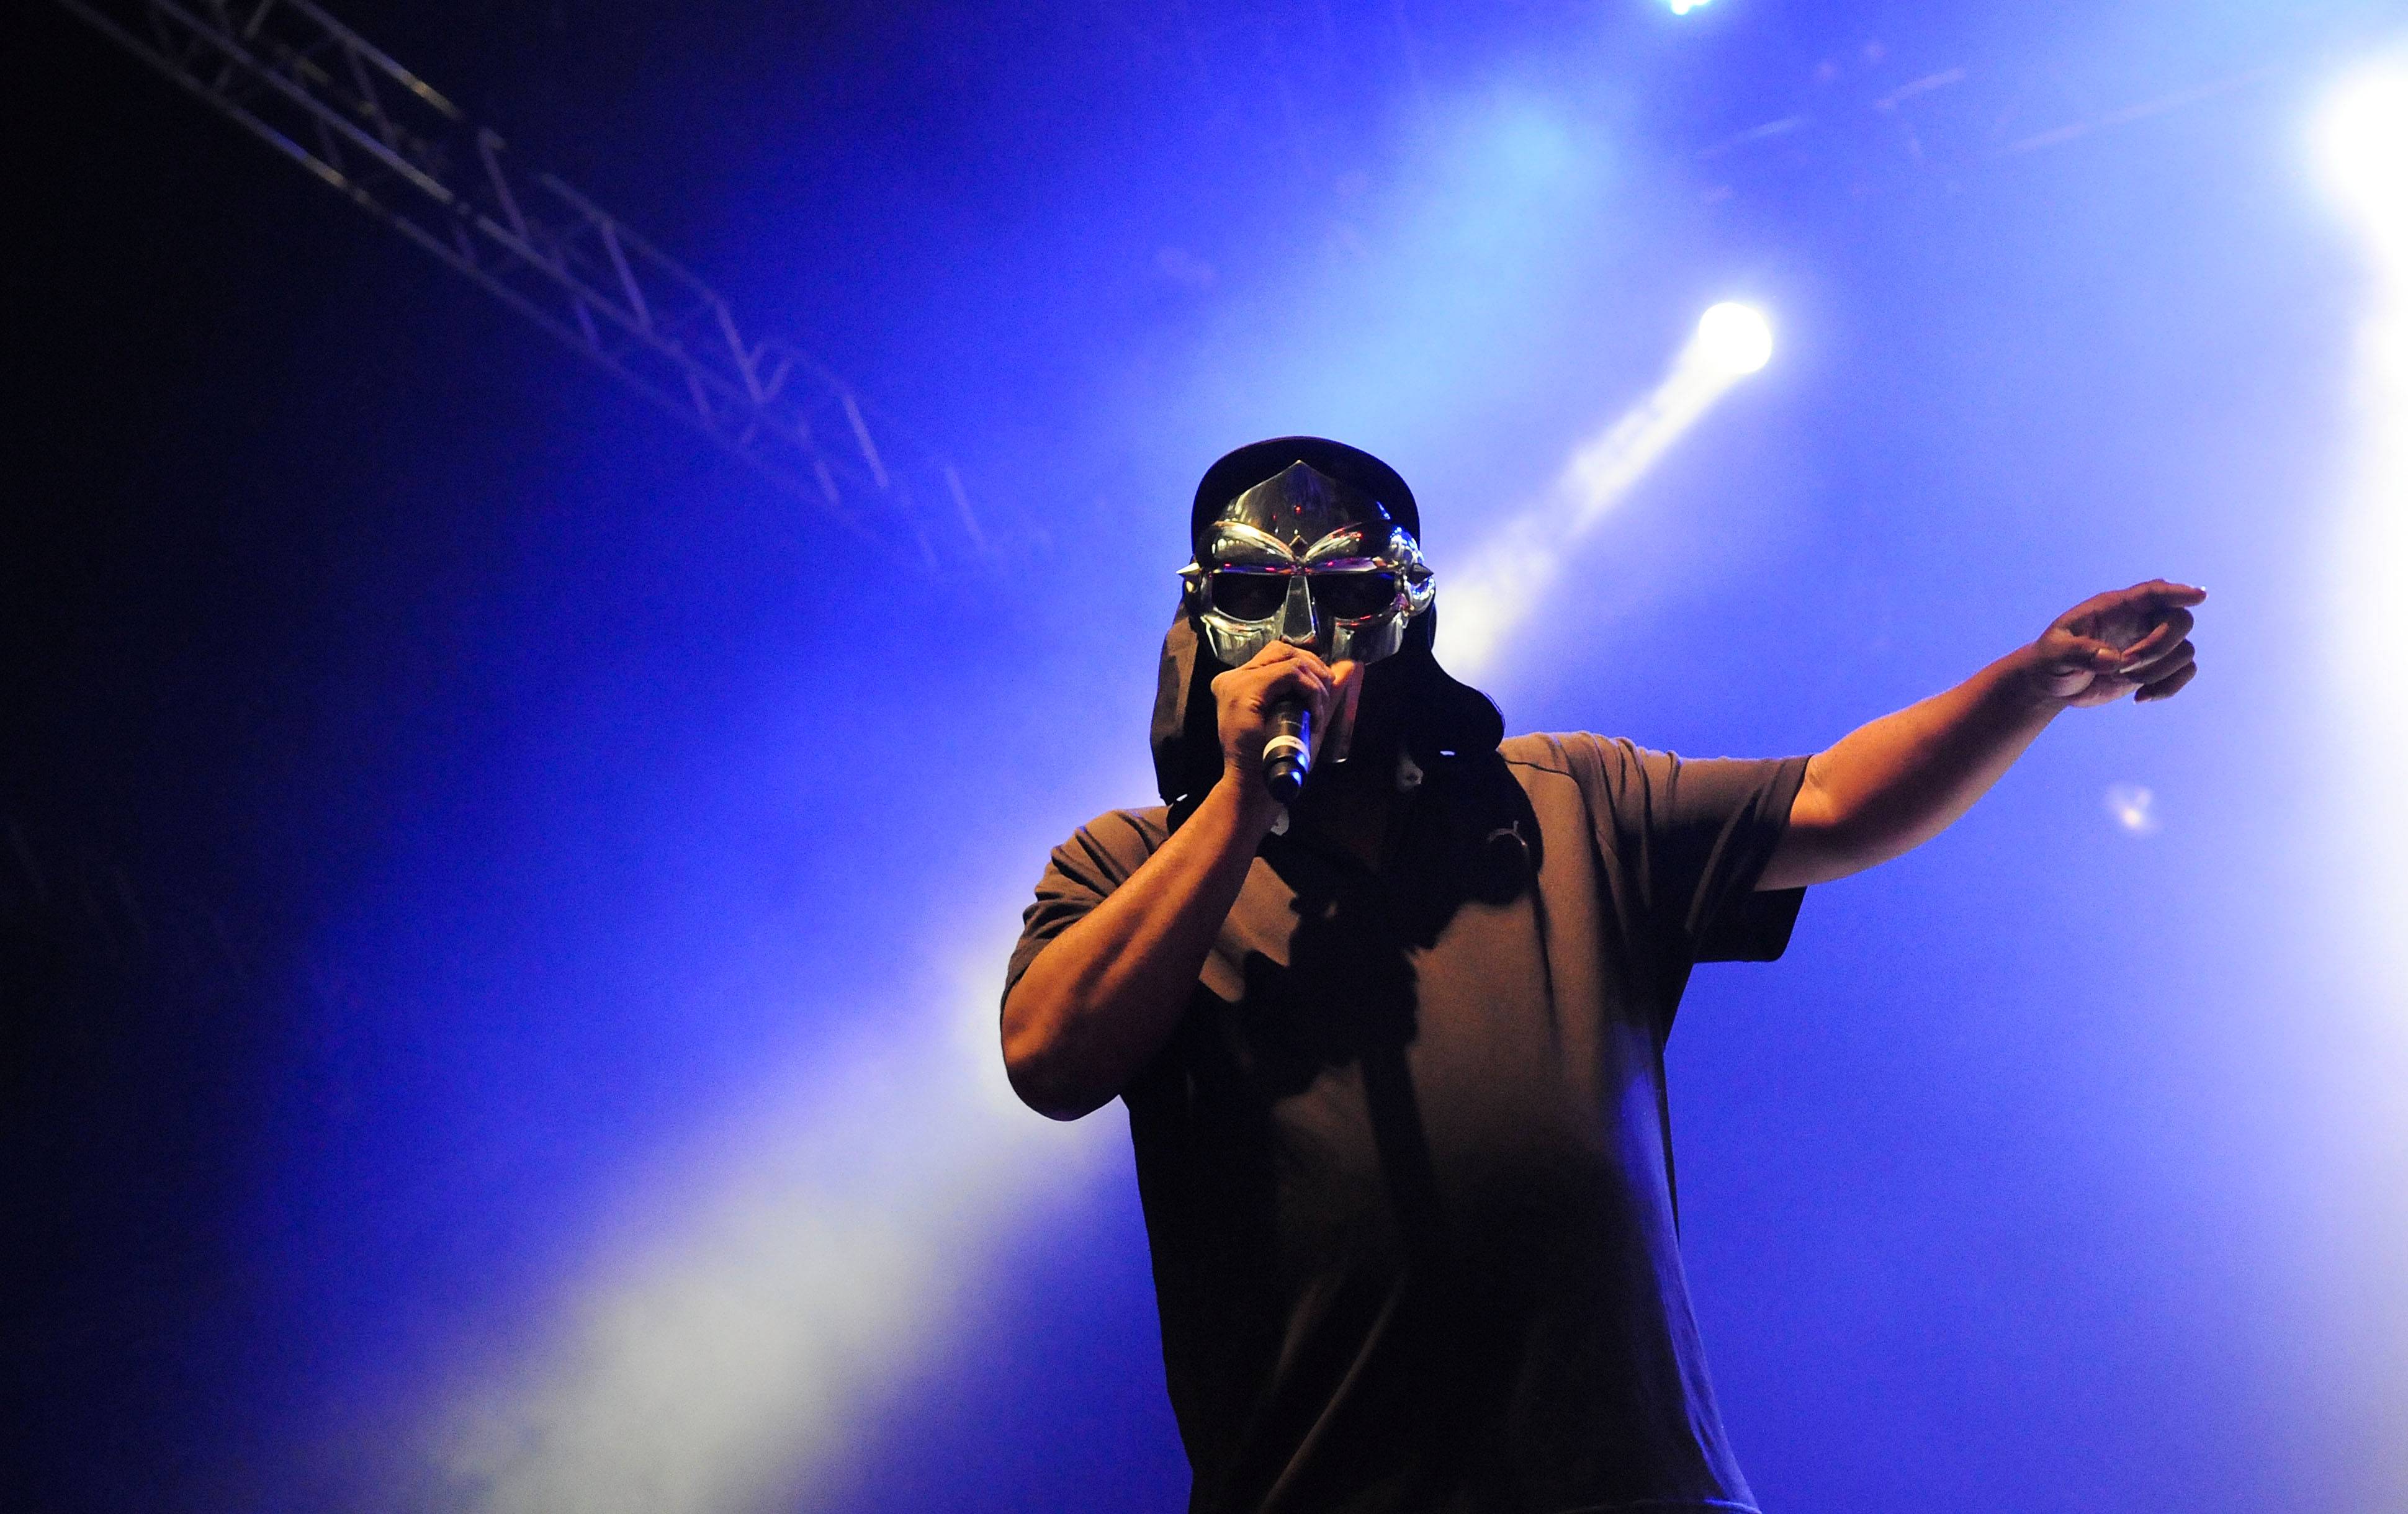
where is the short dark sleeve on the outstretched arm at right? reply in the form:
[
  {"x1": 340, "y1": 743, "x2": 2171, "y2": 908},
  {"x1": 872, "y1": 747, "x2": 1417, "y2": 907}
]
[{"x1": 1563, "y1": 734, "x2": 1806, "y2": 963}]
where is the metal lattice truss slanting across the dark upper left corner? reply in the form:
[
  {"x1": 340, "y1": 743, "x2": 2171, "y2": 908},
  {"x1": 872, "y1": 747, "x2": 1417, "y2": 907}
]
[{"x1": 58, "y1": 0, "x2": 990, "y2": 568}]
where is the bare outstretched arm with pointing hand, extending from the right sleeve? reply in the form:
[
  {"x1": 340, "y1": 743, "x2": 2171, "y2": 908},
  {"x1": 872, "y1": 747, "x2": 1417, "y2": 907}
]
[{"x1": 1756, "y1": 578, "x2": 2208, "y2": 888}]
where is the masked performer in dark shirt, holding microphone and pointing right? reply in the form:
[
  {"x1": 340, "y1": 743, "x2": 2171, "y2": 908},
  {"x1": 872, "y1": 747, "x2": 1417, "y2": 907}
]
[{"x1": 1002, "y1": 438, "x2": 2206, "y2": 1514}]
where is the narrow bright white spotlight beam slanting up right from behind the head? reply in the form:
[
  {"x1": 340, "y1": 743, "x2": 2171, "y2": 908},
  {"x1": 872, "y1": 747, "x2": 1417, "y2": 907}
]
[{"x1": 1442, "y1": 301, "x2": 1772, "y2": 679}]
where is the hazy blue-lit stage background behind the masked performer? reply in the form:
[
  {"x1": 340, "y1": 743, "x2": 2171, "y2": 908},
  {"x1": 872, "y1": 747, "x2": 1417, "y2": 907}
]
[{"x1": 0, "y1": 0, "x2": 2408, "y2": 1514}]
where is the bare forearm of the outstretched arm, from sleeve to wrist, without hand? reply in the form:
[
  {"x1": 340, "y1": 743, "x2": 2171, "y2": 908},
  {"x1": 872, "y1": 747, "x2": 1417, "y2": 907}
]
[{"x1": 1758, "y1": 647, "x2": 2064, "y2": 888}]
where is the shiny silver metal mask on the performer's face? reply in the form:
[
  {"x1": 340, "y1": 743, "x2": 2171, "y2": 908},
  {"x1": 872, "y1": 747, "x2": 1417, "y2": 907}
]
[{"x1": 1180, "y1": 462, "x2": 1437, "y2": 667}]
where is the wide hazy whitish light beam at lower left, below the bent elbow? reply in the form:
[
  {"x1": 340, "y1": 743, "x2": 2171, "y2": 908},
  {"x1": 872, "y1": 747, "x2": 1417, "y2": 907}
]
[{"x1": 411, "y1": 919, "x2": 1117, "y2": 1514}]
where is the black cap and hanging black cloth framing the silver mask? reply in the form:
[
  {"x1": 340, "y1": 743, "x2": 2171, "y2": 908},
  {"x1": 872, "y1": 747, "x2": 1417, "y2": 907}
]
[{"x1": 1154, "y1": 436, "x2": 1505, "y2": 828}]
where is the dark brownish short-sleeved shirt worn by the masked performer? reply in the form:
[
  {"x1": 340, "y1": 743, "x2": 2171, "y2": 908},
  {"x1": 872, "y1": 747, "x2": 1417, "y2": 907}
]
[{"x1": 1007, "y1": 734, "x2": 1806, "y2": 1514}]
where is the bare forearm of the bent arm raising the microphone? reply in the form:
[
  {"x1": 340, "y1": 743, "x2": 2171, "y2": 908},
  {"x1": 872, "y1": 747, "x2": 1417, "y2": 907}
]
[{"x1": 1004, "y1": 782, "x2": 1276, "y2": 1119}]
